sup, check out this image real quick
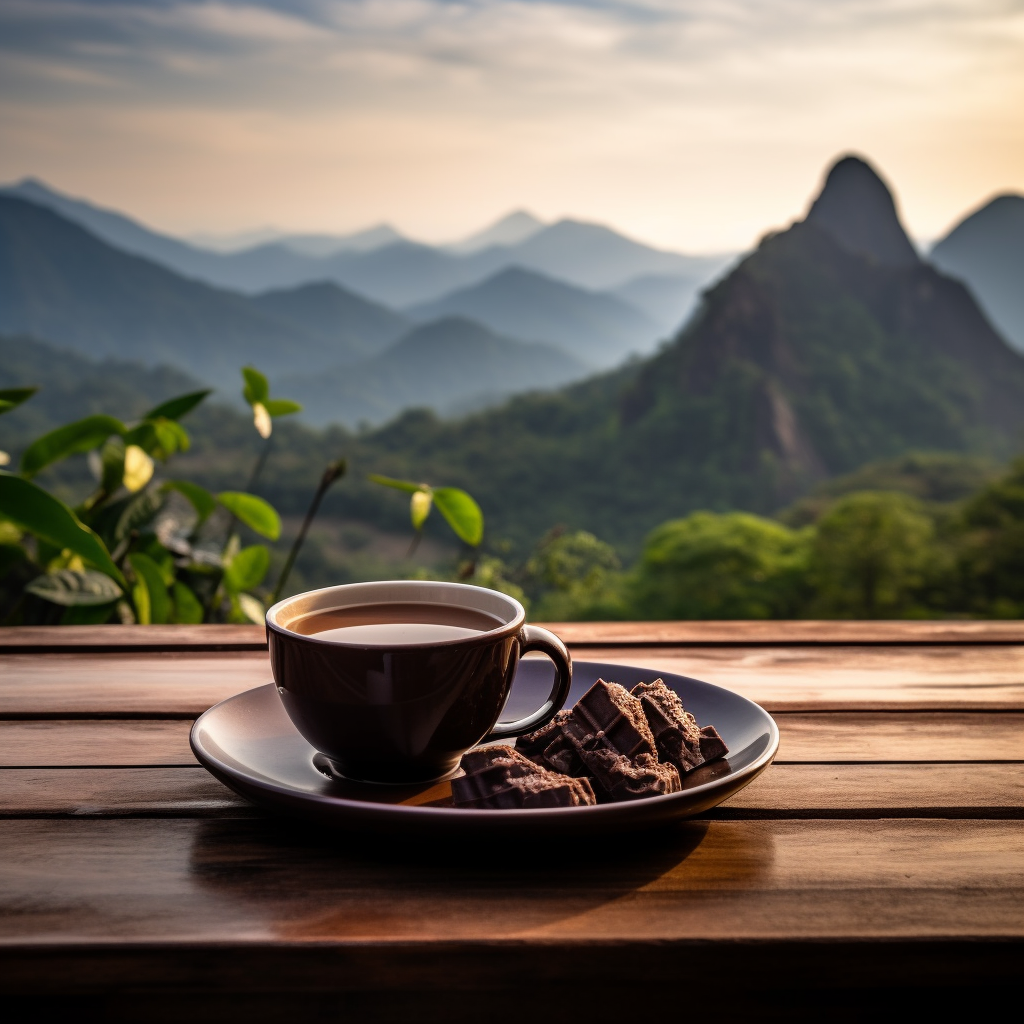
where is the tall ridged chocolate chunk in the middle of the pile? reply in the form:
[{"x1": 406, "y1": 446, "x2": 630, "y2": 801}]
[{"x1": 562, "y1": 679, "x2": 681, "y2": 801}]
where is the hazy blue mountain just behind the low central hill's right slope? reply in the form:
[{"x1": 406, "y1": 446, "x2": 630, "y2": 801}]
[{"x1": 408, "y1": 267, "x2": 658, "y2": 368}]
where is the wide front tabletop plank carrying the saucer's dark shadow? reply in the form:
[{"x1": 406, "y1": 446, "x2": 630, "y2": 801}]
[{"x1": 0, "y1": 819, "x2": 1024, "y2": 942}]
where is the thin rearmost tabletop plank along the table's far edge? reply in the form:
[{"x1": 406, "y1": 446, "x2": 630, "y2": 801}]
[{"x1": 0, "y1": 621, "x2": 1024, "y2": 652}]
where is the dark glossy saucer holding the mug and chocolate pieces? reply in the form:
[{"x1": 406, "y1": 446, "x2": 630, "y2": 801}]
[{"x1": 190, "y1": 659, "x2": 778, "y2": 837}]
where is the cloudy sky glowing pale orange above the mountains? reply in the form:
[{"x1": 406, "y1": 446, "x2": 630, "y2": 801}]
[{"x1": 0, "y1": 0, "x2": 1024, "y2": 252}]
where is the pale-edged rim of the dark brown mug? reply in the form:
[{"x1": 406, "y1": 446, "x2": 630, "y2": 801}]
[{"x1": 265, "y1": 580, "x2": 526, "y2": 650}]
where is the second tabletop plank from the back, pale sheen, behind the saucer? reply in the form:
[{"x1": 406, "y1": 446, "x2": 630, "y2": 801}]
[{"x1": 8, "y1": 646, "x2": 1024, "y2": 718}]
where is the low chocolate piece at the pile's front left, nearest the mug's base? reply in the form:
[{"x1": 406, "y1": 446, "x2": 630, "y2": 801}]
[{"x1": 452, "y1": 745, "x2": 597, "y2": 810}]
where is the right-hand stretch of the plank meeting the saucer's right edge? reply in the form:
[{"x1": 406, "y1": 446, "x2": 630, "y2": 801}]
[{"x1": 775, "y1": 712, "x2": 1024, "y2": 764}]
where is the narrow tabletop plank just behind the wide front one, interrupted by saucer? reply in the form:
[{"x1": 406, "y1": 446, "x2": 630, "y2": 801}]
[{"x1": 0, "y1": 764, "x2": 1024, "y2": 818}]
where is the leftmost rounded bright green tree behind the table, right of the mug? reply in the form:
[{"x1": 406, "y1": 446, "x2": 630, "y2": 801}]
[{"x1": 627, "y1": 512, "x2": 810, "y2": 618}]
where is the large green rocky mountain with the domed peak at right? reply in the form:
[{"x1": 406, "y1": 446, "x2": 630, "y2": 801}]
[{"x1": 346, "y1": 153, "x2": 1024, "y2": 549}]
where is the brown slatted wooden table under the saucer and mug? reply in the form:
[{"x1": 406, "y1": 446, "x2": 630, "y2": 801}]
[{"x1": 0, "y1": 623, "x2": 1024, "y2": 1022}]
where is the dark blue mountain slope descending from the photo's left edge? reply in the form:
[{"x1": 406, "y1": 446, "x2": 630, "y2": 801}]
[{"x1": 0, "y1": 198, "x2": 354, "y2": 390}]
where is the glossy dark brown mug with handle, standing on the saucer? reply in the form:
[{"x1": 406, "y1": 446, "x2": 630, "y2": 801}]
[{"x1": 266, "y1": 580, "x2": 572, "y2": 782}]
